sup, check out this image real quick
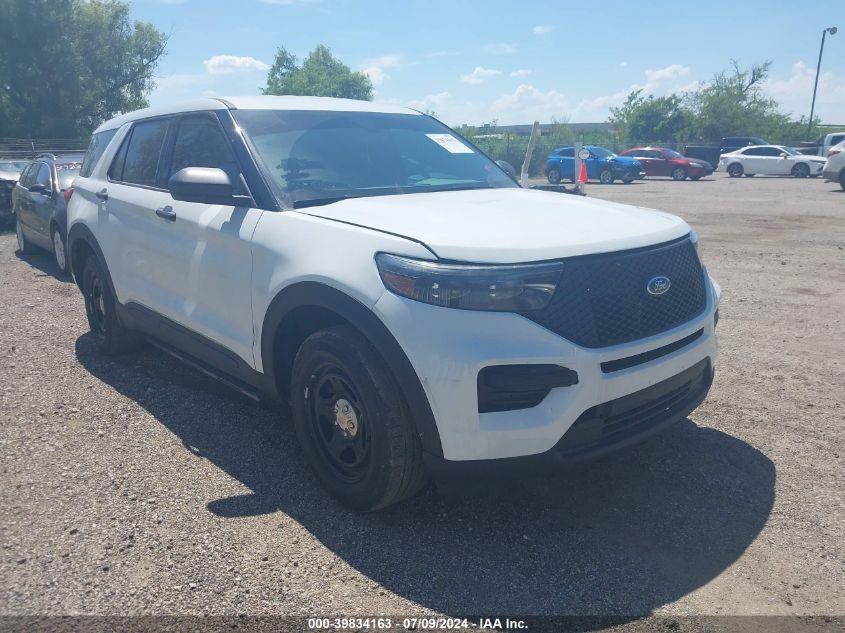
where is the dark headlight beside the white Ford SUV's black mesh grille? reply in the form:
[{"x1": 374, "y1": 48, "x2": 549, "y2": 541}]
[{"x1": 376, "y1": 253, "x2": 563, "y2": 312}]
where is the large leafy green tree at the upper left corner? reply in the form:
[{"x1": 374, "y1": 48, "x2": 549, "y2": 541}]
[{"x1": 0, "y1": 0, "x2": 167, "y2": 138}]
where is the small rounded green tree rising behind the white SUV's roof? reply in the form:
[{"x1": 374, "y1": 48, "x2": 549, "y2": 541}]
[{"x1": 262, "y1": 45, "x2": 373, "y2": 101}]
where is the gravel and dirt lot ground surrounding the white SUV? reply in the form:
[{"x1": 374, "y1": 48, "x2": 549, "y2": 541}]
[{"x1": 0, "y1": 175, "x2": 845, "y2": 616}]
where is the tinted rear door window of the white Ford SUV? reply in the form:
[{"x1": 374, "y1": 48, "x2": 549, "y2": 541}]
[{"x1": 109, "y1": 119, "x2": 170, "y2": 187}]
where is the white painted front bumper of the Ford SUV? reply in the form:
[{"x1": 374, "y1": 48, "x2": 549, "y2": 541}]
[{"x1": 374, "y1": 277, "x2": 719, "y2": 462}]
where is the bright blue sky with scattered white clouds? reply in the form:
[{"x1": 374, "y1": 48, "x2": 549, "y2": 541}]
[{"x1": 137, "y1": 0, "x2": 845, "y2": 125}]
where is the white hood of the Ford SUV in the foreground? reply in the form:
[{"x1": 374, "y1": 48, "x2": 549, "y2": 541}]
[{"x1": 294, "y1": 188, "x2": 690, "y2": 264}]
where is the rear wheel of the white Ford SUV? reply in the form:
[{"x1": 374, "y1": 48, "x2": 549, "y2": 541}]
[{"x1": 82, "y1": 256, "x2": 138, "y2": 355}]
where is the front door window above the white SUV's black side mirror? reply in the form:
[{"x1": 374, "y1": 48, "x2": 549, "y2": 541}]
[{"x1": 168, "y1": 115, "x2": 240, "y2": 184}]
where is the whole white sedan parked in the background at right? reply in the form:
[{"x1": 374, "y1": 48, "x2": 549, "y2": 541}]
[{"x1": 717, "y1": 145, "x2": 826, "y2": 178}]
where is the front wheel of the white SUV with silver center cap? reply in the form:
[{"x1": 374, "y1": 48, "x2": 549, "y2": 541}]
[{"x1": 291, "y1": 326, "x2": 425, "y2": 510}]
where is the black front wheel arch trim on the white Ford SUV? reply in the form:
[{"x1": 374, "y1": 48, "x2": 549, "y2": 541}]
[{"x1": 261, "y1": 281, "x2": 443, "y2": 457}]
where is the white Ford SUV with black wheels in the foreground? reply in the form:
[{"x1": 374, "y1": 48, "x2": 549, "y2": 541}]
[{"x1": 68, "y1": 96, "x2": 719, "y2": 509}]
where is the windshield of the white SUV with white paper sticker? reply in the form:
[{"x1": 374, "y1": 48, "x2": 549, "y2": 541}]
[{"x1": 232, "y1": 110, "x2": 517, "y2": 207}]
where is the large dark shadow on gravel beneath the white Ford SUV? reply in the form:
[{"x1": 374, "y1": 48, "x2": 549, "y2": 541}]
[{"x1": 76, "y1": 334, "x2": 776, "y2": 618}]
